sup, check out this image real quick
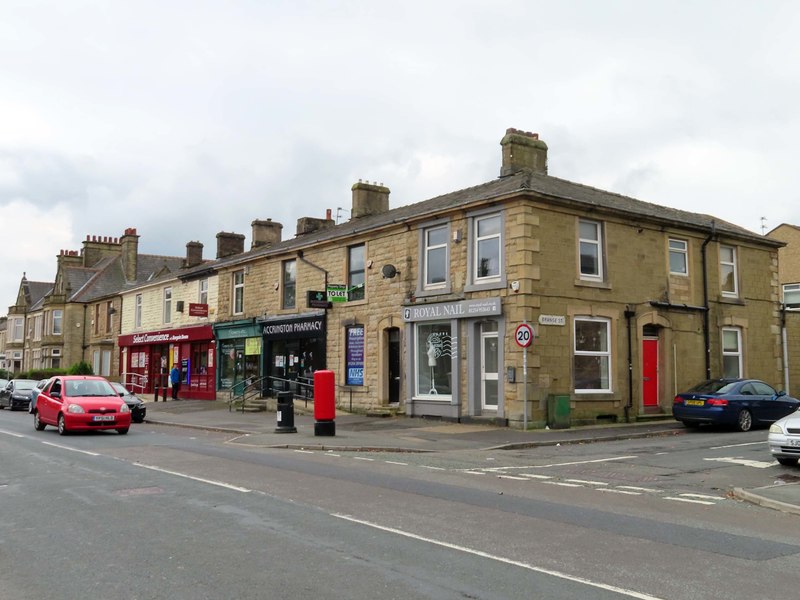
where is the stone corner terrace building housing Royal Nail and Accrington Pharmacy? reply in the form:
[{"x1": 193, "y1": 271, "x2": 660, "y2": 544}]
[{"x1": 197, "y1": 129, "x2": 782, "y2": 427}]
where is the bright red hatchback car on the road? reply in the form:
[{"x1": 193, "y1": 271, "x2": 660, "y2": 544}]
[{"x1": 33, "y1": 375, "x2": 131, "y2": 435}]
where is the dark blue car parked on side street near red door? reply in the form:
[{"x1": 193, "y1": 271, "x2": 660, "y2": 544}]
[{"x1": 672, "y1": 379, "x2": 800, "y2": 431}]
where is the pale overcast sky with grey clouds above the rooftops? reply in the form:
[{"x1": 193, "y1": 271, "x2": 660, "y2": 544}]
[{"x1": 0, "y1": 0, "x2": 800, "y2": 315}]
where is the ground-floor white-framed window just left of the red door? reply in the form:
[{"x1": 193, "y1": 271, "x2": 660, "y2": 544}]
[{"x1": 573, "y1": 317, "x2": 611, "y2": 393}]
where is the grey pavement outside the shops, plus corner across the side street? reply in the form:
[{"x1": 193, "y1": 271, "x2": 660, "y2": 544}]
[{"x1": 142, "y1": 395, "x2": 800, "y2": 516}]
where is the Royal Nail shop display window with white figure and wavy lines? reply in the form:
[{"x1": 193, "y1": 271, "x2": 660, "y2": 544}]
[{"x1": 415, "y1": 322, "x2": 453, "y2": 400}]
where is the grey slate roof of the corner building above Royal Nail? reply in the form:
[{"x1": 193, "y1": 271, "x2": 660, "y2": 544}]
[{"x1": 178, "y1": 170, "x2": 784, "y2": 279}]
